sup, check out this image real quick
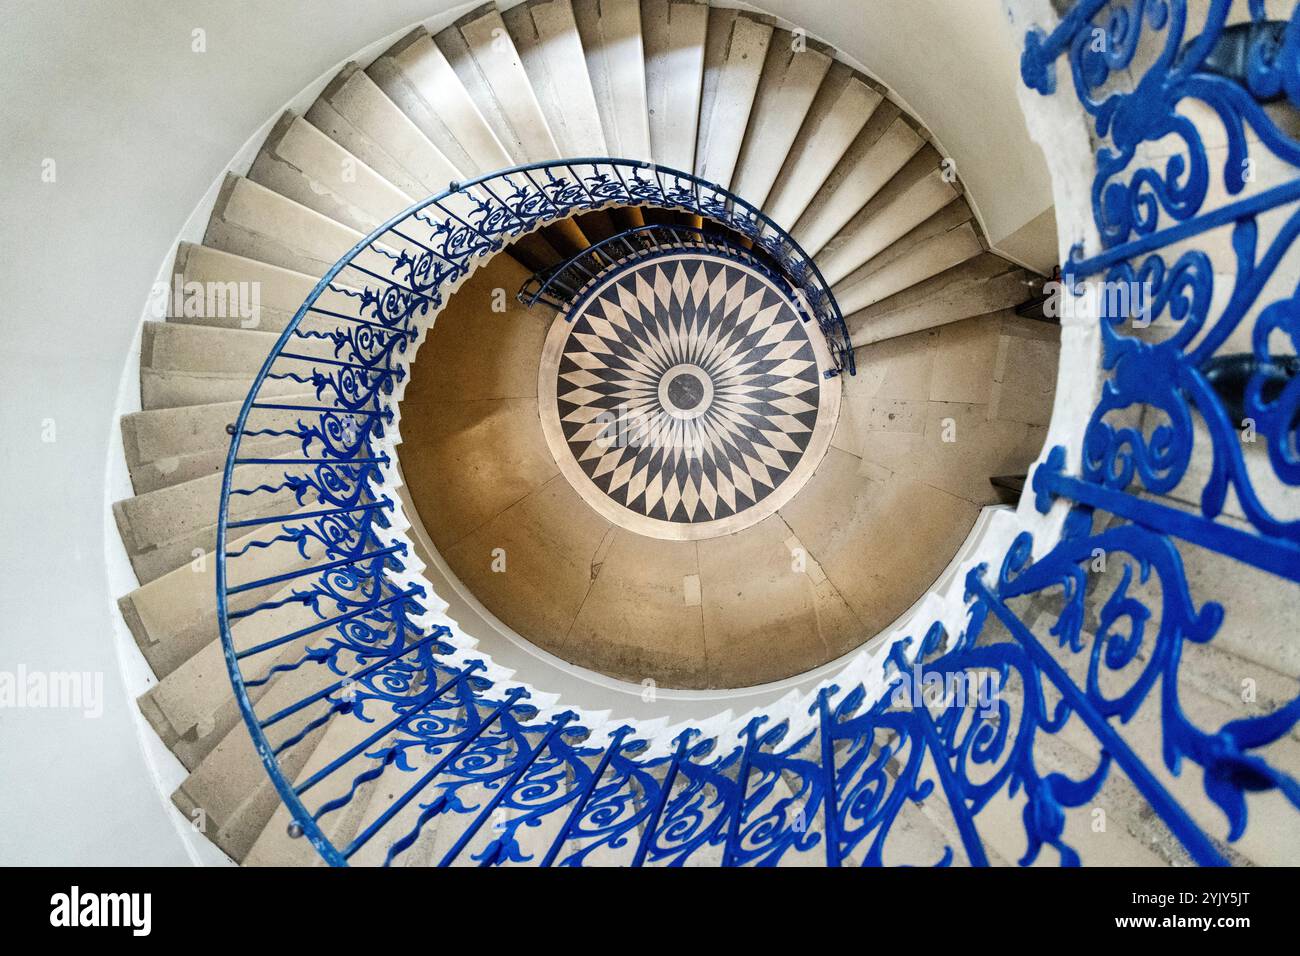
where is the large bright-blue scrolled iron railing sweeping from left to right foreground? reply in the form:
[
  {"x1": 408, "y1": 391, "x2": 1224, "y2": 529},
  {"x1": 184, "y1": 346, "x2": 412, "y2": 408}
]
[{"x1": 217, "y1": 0, "x2": 1300, "y2": 865}]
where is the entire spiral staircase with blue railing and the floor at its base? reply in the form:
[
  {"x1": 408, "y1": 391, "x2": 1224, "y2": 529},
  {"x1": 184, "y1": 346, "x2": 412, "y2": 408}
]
[{"x1": 114, "y1": 0, "x2": 1300, "y2": 865}]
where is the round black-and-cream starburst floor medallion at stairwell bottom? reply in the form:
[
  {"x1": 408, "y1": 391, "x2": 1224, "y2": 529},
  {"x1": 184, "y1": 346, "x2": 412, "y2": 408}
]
[{"x1": 538, "y1": 254, "x2": 839, "y2": 538}]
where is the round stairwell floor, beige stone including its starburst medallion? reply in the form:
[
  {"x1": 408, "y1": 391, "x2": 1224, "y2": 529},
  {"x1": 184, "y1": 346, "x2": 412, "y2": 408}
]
[{"x1": 399, "y1": 196, "x2": 1056, "y2": 689}]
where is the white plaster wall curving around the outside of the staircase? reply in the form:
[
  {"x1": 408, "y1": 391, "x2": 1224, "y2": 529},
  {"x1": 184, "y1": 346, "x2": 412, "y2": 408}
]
[{"x1": 0, "y1": 0, "x2": 1050, "y2": 864}]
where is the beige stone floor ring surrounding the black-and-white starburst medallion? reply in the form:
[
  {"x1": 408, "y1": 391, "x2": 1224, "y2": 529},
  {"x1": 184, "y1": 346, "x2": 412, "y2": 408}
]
[{"x1": 399, "y1": 256, "x2": 1056, "y2": 688}]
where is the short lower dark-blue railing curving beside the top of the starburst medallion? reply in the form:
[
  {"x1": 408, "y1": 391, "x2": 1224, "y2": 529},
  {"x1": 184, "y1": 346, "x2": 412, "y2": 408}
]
[{"x1": 519, "y1": 224, "x2": 790, "y2": 312}]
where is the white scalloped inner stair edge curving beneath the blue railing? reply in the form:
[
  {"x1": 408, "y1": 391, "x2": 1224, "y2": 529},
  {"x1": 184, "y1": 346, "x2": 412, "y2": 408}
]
[{"x1": 356, "y1": 278, "x2": 1101, "y2": 756}]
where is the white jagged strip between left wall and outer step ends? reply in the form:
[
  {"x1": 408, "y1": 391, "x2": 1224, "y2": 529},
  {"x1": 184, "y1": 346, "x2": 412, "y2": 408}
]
[{"x1": 103, "y1": 0, "x2": 493, "y2": 866}]
